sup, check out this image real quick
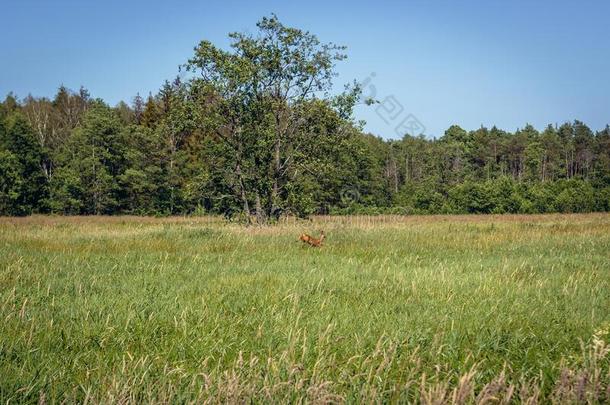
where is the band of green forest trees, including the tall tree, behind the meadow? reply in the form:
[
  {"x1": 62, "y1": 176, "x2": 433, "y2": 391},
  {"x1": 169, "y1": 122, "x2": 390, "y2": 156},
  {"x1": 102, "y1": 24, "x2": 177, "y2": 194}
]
[{"x1": 0, "y1": 15, "x2": 610, "y2": 222}]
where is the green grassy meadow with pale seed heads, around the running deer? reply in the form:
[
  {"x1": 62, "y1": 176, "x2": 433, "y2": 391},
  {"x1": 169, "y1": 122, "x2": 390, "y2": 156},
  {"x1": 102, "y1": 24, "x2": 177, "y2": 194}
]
[{"x1": 0, "y1": 214, "x2": 610, "y2": 403}]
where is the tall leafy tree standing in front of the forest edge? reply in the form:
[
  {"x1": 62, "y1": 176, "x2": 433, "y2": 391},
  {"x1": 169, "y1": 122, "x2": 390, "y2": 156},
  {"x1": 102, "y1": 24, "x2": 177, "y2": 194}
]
[{"x1": 186, "y1": 16, "x2": 355, "y2": 220}]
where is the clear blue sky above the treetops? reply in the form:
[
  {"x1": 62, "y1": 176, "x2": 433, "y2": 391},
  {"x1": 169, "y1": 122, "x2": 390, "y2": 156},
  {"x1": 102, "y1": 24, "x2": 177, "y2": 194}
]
[{"x1": 0, "y1": 0, "x2": 610, "y2": 138}]
